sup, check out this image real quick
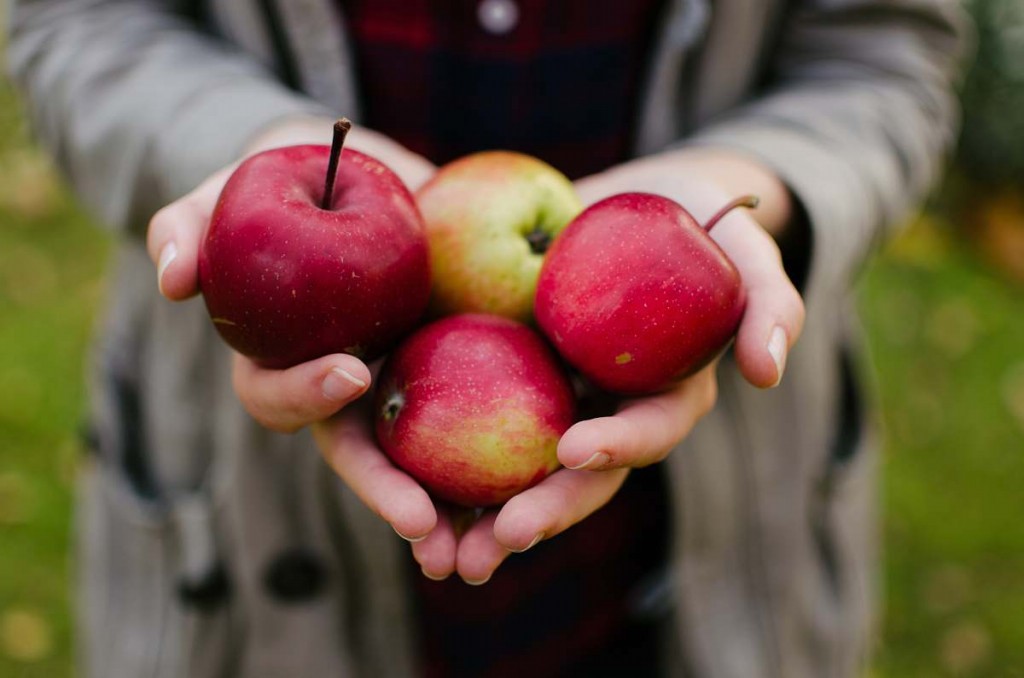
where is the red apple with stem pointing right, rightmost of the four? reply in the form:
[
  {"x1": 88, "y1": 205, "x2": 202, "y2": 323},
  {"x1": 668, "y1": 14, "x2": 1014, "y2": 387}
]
[{"x1": 536, "y1": 193, "x2": 757, "y2": 395}]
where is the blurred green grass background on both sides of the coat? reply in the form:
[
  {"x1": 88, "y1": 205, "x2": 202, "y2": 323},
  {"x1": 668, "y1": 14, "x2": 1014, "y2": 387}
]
[{"x1": 0, "y1": 23, "x2": 1024, "y2": 678}]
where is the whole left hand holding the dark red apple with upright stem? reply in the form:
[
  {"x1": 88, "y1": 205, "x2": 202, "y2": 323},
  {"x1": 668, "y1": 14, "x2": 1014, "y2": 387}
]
[{"x1": 147, "y1": 118, "x2": 454, "y2": 577}]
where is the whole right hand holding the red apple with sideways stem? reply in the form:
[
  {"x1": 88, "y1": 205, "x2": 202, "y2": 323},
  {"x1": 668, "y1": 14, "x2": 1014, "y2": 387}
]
[{"x1": 430, "y1": 150, "x2": 804, "y2": 581}]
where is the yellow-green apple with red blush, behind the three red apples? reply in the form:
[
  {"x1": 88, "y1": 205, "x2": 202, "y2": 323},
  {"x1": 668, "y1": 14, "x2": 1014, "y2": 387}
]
[{"x1": 416, "y1": 151, "x2": 582, "y2": 323}]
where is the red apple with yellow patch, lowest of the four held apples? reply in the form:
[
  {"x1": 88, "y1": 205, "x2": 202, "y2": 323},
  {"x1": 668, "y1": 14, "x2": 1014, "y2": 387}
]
[{"x1": 374, "y1": 313, "x2": 574, "y2": 508}]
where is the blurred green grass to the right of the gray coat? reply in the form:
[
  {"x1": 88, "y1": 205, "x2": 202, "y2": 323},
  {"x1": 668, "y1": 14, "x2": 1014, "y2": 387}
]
[{"x1": 860, "y1": 214, "x2": 1024, "y2": 678}]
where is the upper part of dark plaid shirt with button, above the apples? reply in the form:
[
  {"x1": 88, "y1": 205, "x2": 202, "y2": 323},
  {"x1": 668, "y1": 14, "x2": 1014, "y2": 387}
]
[{"x1": 339, "y1": 0, "x2": 660, "y2": 178}]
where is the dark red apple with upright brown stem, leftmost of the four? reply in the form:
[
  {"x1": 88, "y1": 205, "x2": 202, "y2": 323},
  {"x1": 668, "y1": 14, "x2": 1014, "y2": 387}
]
[{"x1": 199, "y1": 120, "x2": 430, "y2": 368}]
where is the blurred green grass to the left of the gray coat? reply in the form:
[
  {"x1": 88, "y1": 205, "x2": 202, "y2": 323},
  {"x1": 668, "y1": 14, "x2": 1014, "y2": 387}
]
[{"x1": 0, "y1": 59, "x2": 108, "y2": 678}]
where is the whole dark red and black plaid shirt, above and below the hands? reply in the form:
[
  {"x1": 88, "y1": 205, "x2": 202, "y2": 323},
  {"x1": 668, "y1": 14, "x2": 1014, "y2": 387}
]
[{"x1": 339, "y1": 0, "x2": 668, "y2": 678}]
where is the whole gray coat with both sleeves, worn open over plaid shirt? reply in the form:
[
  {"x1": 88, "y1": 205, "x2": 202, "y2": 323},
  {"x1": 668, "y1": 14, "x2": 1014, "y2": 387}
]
[{"x1": 9, "y1": 0, "x2": 961, "y2": 678}]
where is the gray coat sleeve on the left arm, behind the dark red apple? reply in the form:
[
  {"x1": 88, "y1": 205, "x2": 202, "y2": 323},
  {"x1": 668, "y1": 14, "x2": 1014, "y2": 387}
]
[{"x1": 7, "y1": 0, "x2": 326, "y2": 235}]
